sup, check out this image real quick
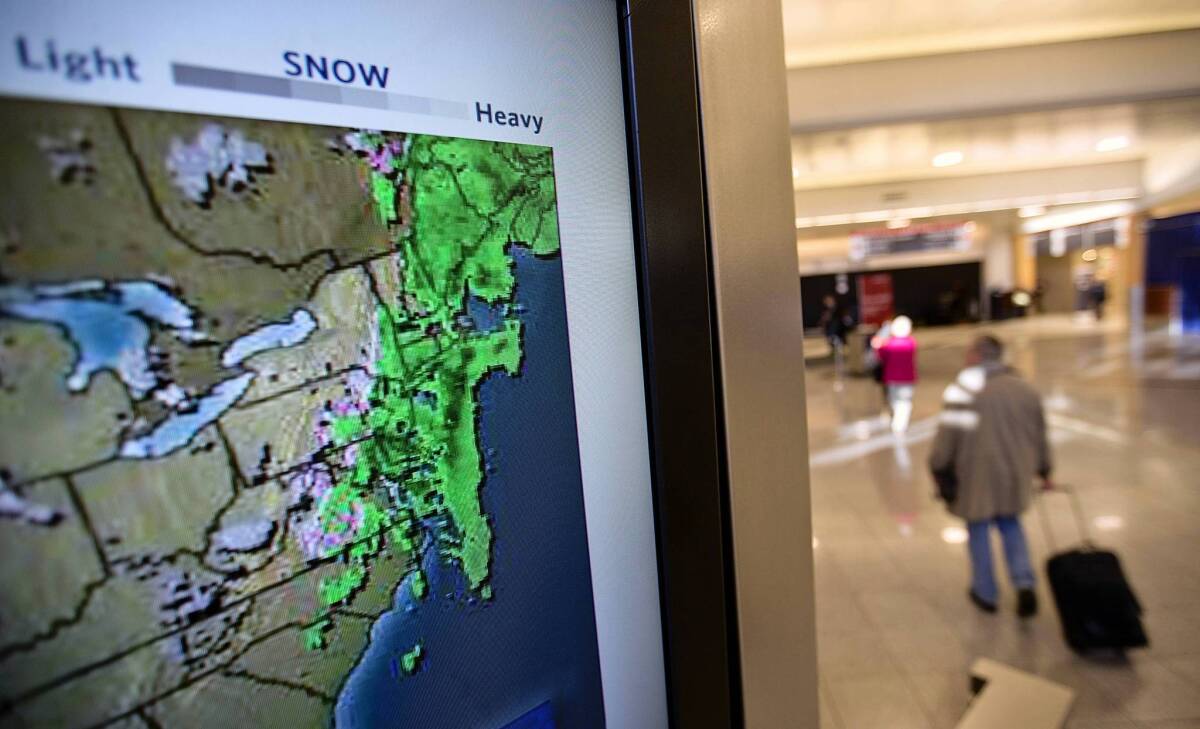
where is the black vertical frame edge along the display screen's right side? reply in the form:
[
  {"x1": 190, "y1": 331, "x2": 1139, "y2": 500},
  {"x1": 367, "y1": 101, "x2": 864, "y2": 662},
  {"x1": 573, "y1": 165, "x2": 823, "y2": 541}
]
[{"x1": 618, "y1": 0, "x2": 743, "y2": 729}]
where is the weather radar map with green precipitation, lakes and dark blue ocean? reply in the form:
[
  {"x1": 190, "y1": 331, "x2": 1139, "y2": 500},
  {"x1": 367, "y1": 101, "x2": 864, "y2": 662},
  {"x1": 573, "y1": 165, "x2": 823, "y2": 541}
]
[{"x1": 0, "y1": 100, "x2": 604, "y2": 729}]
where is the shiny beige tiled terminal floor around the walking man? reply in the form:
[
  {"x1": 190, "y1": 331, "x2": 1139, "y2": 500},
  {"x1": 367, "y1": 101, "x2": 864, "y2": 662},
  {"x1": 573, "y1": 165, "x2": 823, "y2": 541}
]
[{"x1": 806, "y1": 318, "x2": 1200, "y2": 729}]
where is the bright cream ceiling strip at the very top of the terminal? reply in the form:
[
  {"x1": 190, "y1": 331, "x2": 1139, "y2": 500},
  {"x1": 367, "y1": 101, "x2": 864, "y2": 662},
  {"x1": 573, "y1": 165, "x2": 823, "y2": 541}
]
[{"x1": 784, "y1": 0, "x2": 1200, "y2": 68}]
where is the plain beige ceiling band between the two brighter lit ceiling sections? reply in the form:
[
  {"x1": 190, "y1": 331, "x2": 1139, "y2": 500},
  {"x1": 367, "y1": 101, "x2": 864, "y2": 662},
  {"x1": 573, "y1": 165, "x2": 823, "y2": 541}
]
[{"x1": 787, "y1": 27, "x2": 1200, "y2": 132}]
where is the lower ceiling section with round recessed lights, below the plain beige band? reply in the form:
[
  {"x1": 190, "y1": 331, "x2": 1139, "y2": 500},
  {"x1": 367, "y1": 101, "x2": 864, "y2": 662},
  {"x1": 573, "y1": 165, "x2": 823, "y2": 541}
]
[{"x1": 792, "y1": 96, "x2": 1200, "y2": 229}]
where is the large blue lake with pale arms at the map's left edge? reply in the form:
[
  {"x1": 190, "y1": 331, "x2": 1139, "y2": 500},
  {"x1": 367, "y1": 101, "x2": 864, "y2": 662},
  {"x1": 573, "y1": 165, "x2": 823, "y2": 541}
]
[{"x1": 0, "y1": 281, "x2": 192, "y2": 398}]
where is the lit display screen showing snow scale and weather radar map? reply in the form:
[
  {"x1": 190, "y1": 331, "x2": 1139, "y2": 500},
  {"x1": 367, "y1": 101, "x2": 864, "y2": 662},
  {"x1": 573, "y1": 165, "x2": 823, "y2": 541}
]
[{"x1": 0, "y1": 1, "x2": 665, "y2": 729}]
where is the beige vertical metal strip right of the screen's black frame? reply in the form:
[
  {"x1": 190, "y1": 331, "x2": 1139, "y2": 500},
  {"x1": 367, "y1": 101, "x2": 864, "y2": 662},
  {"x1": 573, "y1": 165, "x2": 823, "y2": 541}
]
[{"x1": 694, "y1": 0, "x2": 820, "y2": 729}]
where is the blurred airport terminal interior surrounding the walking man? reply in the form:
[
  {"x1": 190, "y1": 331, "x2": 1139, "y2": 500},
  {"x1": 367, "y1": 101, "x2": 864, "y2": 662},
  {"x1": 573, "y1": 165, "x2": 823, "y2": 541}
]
[{"x1": 784, "y1": 0, "x2": 1200, "y2": 729}]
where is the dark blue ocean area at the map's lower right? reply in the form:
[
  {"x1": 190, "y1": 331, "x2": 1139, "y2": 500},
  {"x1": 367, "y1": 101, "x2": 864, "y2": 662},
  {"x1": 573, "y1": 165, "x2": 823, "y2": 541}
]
[{"x1": 336, "y1": 248, "x2": 605, "y2": 729}]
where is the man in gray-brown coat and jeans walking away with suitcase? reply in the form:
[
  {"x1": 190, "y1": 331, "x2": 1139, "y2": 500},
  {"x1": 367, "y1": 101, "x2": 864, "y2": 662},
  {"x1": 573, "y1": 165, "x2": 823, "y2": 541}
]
[{"x1": 929, "y1": 336, "x2": 1051, "y2": 617}]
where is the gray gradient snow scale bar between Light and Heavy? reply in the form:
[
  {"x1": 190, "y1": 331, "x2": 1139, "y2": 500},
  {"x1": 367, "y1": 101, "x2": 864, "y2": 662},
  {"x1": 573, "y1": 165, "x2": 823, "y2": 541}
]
[{"x1": 170, "y1": 64, "x2": 469, "y2": 119}]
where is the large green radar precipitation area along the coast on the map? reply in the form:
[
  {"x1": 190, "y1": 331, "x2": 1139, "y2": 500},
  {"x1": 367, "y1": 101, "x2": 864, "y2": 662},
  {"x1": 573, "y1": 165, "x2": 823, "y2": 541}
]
[{"x1": 304, "y1": 132, "x2": 558, "y2": 633}]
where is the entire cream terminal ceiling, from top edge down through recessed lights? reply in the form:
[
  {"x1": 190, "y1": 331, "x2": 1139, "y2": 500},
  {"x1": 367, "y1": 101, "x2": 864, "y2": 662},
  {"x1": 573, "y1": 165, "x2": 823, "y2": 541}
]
[{"x1": 782, "y1": 0, "x2": 1200, "y2": 230}]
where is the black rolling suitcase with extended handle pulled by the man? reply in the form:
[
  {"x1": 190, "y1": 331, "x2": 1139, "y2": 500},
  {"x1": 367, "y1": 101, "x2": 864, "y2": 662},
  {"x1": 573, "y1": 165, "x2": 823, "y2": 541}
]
[{"x1": 1038, "y1": 488, "x2": 1150, "y2": 653}]
